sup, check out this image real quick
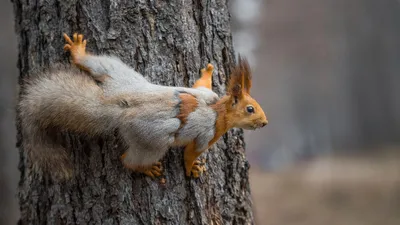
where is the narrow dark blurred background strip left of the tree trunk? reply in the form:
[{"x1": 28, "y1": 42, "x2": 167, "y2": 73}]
[{"x1": 0, "y1": 1, "x2": 19, "y2": 224}]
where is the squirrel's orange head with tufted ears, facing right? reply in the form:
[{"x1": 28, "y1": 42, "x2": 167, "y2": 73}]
[{"x1": 227, "y1": 56, "x2": 268, "y2": 130}]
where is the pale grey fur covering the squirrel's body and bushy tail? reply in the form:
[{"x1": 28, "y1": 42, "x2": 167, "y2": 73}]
[{"x1": 19, "y1": 55, "x2": 218, "y2": 177}]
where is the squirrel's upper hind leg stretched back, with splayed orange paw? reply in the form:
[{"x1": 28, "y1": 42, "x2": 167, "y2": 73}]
[{"x1": 64, "y1": 33, "x2": 139, "y2": 82}]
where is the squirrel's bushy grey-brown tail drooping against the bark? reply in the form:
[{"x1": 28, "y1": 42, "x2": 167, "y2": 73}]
[{"x1": 18, "y1": 66, "x2": 121, "y2": 178}]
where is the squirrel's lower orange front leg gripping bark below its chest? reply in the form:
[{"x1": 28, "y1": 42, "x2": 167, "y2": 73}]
[{"x1": 184, "y1": 142, "x2": 206, "y2": 178}]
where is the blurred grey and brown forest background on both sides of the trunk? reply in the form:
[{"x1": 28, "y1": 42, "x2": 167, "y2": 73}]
[{"x1": 0, "y1": 0, "x2": 400, "y2": 225}]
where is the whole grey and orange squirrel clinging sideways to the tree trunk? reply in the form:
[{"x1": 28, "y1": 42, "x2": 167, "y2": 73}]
[{"x1": 18, "y1": 33, "x2": 268, "y2": 178}]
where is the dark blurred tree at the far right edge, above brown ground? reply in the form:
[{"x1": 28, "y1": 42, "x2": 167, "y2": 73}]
[{"x1": 342, "y1": 0, "x2": 400, "y2": 149}]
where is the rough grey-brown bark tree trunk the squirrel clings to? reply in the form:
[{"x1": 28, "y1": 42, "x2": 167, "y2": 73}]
[{"x1": 13, "y1": 0, "x2": 253, "y2": 224}]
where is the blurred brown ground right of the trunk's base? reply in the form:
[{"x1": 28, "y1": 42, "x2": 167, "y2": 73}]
[{"x1": 250, "y1": 151, "x2": 400, "y2": 225}]
